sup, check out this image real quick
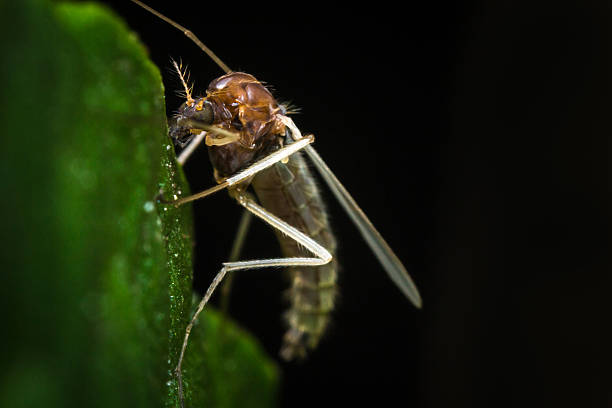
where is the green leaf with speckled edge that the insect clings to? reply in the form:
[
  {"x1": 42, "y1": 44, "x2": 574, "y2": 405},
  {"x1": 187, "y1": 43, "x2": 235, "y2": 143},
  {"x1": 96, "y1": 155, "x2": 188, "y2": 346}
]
[{"x1": 0, "y1": 0, "x2": 278, "y2": 407}]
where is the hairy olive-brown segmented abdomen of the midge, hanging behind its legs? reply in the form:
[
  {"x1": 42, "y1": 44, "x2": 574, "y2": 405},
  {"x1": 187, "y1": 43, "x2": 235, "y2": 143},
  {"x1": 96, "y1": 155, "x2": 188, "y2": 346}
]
[{"x1": 252, "y1": 154, "x2": 338, "y2": 360}]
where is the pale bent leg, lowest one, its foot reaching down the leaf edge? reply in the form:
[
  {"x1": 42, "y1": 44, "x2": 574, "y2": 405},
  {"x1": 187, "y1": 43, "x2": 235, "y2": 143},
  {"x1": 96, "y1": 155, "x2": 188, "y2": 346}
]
[{"x1": 175, "y1": 189, "x2": 332, "y2": 407}]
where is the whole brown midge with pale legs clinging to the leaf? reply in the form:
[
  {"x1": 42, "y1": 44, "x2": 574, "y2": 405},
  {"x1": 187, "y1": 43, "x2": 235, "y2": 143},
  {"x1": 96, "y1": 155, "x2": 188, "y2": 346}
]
[{"x1": 131, "y1": 0, "x2": 422, "y2": 406}]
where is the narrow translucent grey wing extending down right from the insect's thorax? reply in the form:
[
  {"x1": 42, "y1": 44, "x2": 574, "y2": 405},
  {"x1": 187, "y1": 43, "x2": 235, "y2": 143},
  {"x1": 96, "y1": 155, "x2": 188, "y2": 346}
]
[{"x1": 304, "y1": 146, "x2": 423, "y2": 308}]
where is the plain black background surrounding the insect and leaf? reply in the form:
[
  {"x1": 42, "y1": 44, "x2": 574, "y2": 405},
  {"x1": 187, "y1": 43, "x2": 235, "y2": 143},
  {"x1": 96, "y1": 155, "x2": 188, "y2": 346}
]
[{"x1": 106, "y1": 0, "x2": 612, "y2": 407}]
